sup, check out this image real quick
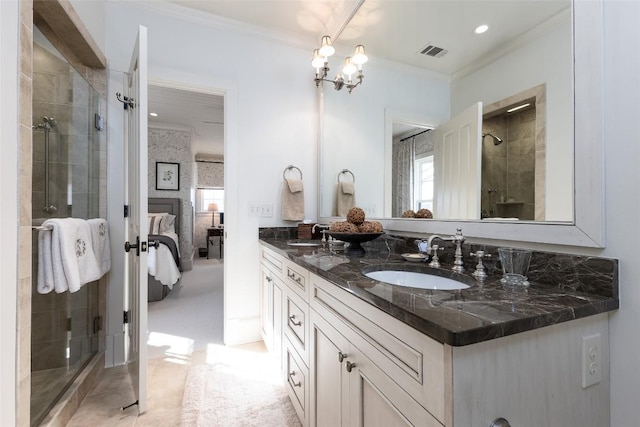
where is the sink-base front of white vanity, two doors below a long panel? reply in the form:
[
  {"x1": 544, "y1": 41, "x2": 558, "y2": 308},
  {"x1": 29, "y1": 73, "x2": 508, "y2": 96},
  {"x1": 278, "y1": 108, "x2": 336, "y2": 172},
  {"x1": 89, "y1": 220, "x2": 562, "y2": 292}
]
[{"x1": 310, "y1": 273, "x2": 445, "y2": 427}]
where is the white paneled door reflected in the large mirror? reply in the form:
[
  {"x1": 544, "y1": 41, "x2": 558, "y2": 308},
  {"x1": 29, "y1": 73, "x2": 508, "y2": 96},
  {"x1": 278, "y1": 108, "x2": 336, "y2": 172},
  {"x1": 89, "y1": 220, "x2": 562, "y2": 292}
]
[{"x1": 433, "y1": 102, "x2": 482, "y2": 219}]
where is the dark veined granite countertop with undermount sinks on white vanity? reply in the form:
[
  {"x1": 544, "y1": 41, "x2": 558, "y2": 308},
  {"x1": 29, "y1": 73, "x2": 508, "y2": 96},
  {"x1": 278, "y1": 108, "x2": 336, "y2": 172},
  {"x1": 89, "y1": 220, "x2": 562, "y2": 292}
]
[{"x1": 261, "y1": 236, "x2": 619, "y2": 346}]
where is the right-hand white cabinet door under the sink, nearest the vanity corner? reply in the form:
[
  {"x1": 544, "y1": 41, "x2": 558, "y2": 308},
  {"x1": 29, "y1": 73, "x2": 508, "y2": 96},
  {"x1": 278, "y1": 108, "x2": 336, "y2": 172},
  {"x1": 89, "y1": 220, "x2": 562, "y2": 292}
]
[{"x1": 345, "y1": 345, "x2": 442, "y2": 427}]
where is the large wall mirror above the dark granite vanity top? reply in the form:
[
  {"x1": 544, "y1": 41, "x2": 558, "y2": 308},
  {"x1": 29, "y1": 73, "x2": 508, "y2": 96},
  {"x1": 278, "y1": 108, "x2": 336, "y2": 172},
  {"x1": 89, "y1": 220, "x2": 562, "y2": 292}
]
[{"x1": 321, "y1": 0, "x2": 573, "y2": 222}]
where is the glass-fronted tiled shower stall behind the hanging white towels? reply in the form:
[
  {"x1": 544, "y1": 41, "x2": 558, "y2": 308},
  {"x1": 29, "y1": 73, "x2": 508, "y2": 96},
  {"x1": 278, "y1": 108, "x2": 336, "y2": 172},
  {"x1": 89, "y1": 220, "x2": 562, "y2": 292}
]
[{"x1": 31, "y1": 28, "x2": 105, "y2": 426}]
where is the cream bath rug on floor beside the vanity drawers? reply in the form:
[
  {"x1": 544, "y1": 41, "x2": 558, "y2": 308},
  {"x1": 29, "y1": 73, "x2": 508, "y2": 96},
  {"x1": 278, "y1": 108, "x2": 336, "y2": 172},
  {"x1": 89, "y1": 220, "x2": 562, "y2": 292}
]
[{"x1": 181, "y1": 348, "x2": 301, "y2": 427}]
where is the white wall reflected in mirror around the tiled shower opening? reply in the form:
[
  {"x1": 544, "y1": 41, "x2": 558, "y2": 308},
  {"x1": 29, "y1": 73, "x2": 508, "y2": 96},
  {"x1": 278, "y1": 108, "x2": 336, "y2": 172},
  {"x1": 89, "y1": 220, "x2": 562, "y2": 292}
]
[{"x1": 451, "y1": 13, "x2": 573, "y2": 221}]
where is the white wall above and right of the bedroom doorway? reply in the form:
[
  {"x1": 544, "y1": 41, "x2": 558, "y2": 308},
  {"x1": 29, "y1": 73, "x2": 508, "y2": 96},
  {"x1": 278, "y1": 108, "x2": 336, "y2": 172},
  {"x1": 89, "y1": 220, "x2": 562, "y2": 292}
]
[{"x1": 106, "y1": 2, "x2": 317, "y2": 352}]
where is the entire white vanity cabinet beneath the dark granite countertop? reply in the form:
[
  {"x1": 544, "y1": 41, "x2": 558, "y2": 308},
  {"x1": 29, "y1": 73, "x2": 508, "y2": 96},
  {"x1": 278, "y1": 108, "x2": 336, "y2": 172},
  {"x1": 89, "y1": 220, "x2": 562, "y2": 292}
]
[{"x1": 261, "y1": 244, "x2": 610, "y2": 427}]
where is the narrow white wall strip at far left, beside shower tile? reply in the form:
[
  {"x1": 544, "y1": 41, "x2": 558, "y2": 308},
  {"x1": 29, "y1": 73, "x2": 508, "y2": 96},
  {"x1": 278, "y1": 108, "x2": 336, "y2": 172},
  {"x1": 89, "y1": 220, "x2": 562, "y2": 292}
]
[{"x1": 0, "y1": 1, "x2": 20, "y2": 426}]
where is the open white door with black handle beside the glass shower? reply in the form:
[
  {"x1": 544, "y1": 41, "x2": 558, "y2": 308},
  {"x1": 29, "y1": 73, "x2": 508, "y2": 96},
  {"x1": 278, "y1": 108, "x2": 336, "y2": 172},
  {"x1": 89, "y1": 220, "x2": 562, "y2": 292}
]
[{"x1": 123, "y1": 26, "x2": 149, "y2": 413}]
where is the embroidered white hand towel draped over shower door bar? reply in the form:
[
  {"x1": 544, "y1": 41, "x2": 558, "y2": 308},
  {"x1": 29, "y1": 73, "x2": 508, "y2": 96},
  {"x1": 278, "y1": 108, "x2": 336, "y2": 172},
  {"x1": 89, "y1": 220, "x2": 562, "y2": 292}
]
[{"x1": 45, "y1": 218, "x2": 102, "y2": 293}]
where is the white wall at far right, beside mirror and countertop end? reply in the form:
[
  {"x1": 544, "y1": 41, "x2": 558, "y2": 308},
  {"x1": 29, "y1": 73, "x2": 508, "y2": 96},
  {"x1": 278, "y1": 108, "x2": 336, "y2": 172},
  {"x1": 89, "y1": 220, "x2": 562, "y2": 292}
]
[{"x1": 602, "y1": 1, "x2": 640, "y2": 427}]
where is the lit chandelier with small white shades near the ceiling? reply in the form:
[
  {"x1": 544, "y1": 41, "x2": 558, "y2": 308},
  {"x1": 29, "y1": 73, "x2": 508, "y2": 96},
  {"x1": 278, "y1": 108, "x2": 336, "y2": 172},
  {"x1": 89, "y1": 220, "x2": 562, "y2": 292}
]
[{"x1": 311, "y1": 36, "x2": 369, "y2": 93}]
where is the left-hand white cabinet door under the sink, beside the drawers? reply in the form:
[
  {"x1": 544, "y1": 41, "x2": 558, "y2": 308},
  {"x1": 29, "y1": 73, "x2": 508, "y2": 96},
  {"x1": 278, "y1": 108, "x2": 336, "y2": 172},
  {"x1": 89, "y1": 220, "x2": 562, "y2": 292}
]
[{"x1": 310, "y1": 310, "x2": 350, "y2": 427}]
